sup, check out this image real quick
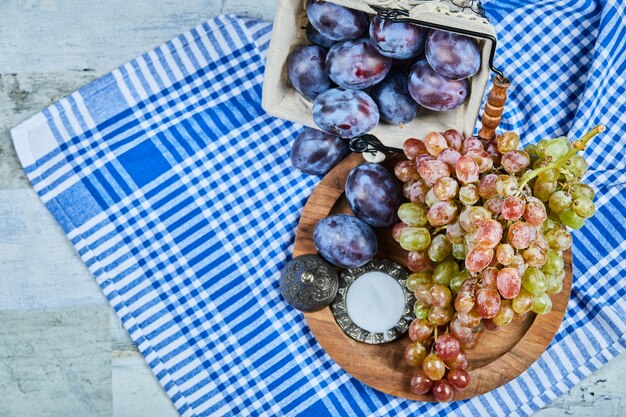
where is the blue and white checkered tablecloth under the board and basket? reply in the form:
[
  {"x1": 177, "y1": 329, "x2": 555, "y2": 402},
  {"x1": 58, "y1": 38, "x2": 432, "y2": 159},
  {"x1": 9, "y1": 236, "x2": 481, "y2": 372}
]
[{"x1": 12, "y1": 0, "x2": 626, "y2": 417}]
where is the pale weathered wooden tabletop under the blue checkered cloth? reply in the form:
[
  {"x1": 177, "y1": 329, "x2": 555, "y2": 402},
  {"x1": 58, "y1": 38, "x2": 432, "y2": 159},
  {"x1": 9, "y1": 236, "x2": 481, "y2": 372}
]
[{"x1": 0, "y1": 0, "x2": 626, "y2": 417}]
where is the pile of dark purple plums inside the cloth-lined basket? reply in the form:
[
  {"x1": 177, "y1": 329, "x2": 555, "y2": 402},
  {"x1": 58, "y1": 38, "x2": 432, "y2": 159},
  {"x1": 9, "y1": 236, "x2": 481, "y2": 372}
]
[{"x1": 287, "y1": 0, "x2": 481, "y2": 138}]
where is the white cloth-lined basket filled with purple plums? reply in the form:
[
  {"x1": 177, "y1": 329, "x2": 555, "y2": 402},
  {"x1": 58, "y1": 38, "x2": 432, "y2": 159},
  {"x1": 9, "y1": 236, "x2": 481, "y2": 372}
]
[{"x1": 263, "y1": 0, "x2": 496, "y2": 147}]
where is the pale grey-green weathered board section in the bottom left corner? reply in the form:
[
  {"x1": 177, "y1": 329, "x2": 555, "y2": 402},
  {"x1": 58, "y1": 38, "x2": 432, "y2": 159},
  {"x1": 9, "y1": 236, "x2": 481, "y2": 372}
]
[{"x1": 0, "y1": 305, "x2": 113, "y2": 417}]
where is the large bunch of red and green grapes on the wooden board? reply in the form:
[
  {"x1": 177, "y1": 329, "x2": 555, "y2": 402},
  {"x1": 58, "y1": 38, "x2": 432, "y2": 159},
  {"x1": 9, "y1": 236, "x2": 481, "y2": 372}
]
[{"x1": 392, "y1": 126, "x2": 604, "y2": 401}]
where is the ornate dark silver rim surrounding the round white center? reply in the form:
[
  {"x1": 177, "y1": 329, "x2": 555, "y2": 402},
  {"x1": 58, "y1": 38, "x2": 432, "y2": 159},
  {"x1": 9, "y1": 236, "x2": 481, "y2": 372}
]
[{"x1": 331, "y1": 258, "x2": 416, "y2": 345}]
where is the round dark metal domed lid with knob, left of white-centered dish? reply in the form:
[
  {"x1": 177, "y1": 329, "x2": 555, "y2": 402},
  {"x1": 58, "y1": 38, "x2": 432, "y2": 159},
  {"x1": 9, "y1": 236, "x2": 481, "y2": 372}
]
[{"x1": 280, "y1": 255, "x2": 339, "y2": 313}]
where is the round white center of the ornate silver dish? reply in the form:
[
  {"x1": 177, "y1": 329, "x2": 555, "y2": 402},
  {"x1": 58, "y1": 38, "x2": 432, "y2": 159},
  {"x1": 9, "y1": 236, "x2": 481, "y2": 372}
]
[{"x1": 346, "y1": 271, "x2": 404, "y2": 333}]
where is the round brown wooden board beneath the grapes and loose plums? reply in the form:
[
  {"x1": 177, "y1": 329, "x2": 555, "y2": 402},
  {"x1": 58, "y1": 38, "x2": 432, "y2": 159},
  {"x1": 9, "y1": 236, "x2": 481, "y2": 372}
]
[{"x1": 294, "y1": 154, "x2": 572, "y2": 401}]
